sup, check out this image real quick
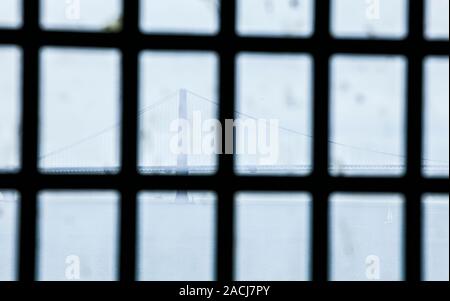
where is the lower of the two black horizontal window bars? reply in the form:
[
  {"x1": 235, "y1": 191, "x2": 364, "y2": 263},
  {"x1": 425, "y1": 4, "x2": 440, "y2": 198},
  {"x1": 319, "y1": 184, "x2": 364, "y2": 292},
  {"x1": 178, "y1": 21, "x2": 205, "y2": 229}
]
[{"x1": 0, "y1": 174, "x2": 448, "y2": 193}]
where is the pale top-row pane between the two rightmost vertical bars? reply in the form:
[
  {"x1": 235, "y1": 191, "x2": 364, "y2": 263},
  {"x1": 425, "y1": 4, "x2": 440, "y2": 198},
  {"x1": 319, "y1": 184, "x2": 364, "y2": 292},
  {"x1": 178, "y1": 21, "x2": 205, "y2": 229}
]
[{"x1": 331, "y1": 0, "x2": 408, "y2": 39}]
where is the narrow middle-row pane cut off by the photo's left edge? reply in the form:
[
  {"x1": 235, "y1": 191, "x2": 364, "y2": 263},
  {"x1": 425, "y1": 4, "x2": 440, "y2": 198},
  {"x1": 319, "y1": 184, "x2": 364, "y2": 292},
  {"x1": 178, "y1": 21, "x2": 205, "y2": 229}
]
[{"x1": 0, "y1": 46, "x2": 22, "y2": 172}]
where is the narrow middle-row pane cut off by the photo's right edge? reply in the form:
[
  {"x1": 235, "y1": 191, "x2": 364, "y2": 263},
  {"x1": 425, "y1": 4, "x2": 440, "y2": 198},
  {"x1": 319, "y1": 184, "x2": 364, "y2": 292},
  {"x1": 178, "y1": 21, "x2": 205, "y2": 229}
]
[{"x1": 423, "y1": 57, "x2": 449, "y2": 177}]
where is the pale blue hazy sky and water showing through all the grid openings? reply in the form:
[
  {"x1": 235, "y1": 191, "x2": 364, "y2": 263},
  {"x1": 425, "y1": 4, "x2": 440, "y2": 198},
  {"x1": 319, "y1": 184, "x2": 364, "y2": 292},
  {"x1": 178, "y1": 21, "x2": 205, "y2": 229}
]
[{"x1": 0, "y1": 0, "x2": 449, "y2": 281}]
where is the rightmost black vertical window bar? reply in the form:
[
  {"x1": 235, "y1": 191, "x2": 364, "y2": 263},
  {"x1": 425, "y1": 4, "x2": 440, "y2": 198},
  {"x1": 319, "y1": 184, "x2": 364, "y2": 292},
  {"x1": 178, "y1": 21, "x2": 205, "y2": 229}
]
[{"x1": 404, "y1": 0, "x2": 425, "y2": 282}]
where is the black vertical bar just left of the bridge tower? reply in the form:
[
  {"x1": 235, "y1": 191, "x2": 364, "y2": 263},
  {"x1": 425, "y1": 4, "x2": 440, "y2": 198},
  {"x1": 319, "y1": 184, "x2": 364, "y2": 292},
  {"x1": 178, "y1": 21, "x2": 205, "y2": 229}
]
[{"x1": 119, "y1": 0, "x2": 139, "y2": 282}]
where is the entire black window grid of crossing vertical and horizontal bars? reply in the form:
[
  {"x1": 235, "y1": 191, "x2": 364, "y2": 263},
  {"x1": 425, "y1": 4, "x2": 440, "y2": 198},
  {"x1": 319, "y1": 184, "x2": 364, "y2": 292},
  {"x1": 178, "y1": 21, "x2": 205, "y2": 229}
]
[{"x1": 0, "y1": 0, "x2": 449, "y2": 282}]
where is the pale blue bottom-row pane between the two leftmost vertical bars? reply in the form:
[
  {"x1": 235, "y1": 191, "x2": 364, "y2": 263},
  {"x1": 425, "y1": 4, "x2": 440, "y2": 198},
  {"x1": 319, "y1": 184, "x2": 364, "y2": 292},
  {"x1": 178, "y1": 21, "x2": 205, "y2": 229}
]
[{"x1": 38, "y1": 191, "x2": 118, "y2": 281}]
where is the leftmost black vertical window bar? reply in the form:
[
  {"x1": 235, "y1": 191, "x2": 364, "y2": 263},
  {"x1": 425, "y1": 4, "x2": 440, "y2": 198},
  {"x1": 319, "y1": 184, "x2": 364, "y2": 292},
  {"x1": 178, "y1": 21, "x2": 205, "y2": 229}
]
[{"x1": 18, "y1": 1, "x2": 39, "y2": 282}]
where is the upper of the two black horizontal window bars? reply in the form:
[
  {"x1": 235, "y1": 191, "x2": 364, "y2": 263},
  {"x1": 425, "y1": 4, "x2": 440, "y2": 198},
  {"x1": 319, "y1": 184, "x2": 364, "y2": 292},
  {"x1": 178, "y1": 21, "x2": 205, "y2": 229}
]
[{"x1": 0, "y1": 29, "x2": 450, "y2": 55}]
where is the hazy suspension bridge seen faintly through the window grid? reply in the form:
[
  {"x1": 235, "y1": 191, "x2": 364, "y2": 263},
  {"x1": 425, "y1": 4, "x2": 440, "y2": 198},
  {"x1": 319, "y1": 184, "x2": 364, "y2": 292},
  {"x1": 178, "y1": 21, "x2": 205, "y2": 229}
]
[{"x1": 4, "y1": 89, "x2": 449, "y2": 175}]
